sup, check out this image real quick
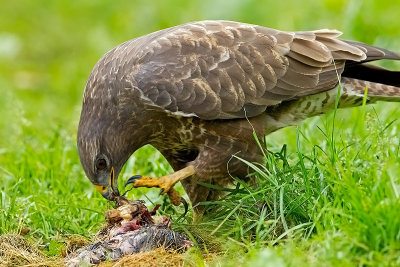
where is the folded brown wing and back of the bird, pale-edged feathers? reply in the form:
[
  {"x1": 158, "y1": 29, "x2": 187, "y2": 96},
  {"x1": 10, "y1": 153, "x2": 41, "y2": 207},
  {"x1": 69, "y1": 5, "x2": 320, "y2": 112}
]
[{"x1": 84, "y1": 21, "x2": 394, "y2": 120}]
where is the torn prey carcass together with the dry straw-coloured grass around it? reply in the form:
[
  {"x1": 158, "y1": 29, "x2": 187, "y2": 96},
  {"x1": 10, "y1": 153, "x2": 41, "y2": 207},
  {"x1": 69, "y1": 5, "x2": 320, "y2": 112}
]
[{"x1": 0, "y1": 197, "x2": 219, "y2": 267}]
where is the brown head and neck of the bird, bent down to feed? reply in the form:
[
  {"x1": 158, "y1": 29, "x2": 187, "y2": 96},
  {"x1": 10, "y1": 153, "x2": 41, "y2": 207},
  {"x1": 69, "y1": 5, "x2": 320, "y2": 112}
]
[{"x1": 77, "y1": 47, "x2": 159, "y2": 200}]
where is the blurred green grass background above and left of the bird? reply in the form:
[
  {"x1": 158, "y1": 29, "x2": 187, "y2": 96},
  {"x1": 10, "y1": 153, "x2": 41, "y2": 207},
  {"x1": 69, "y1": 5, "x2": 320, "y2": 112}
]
[{"x1": 0, "y1": 0, "x2": 400, "y2": 241}]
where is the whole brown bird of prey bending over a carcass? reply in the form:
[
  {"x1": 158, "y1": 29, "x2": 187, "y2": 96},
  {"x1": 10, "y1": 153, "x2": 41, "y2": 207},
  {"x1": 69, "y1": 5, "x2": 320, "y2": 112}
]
[{"x1": 77, "y1": 21, "x2": 400, "y2": 216}]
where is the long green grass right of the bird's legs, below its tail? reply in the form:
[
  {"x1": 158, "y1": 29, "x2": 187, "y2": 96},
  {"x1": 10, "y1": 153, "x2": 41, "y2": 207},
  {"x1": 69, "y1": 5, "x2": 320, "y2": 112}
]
[{"x1": 195, "y1": 109, "x2": 400, "y2": 266}]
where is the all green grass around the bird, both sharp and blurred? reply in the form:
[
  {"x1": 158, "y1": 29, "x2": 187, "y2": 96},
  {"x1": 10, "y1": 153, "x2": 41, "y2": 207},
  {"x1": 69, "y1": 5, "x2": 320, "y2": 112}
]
[{"x1": 0, "y1": 0, "x2": 400, "y2": 266}]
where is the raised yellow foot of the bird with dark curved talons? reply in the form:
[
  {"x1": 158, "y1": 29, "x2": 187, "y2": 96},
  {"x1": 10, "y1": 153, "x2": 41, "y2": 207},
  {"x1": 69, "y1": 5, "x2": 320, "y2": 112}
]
[{"x1": 125, "y1": 165, "x2": 195, "y2": 210}]
